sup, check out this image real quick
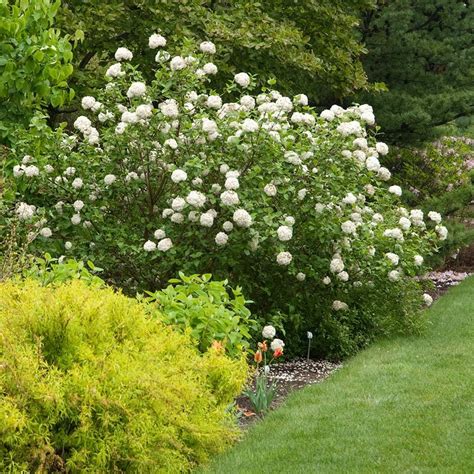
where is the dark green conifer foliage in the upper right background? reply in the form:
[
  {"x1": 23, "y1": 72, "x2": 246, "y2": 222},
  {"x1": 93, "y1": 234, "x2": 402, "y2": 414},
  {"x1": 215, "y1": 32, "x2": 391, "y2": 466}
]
[{"x1": 359, "y1": 0, "x2": 474, "y2": 142}]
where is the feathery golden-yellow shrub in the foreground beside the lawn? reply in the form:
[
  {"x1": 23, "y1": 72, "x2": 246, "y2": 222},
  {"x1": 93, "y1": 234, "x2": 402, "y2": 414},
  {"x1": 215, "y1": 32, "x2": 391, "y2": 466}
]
[{"x1": 0, "y1": 281, "x2": 246, "y2": 473}]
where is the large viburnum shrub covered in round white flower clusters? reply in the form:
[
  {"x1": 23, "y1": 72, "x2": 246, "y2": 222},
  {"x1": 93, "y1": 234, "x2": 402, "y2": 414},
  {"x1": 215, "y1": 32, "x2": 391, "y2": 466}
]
[{"x1": 5, "y1": 34, "x2": 446, "y2": 355}]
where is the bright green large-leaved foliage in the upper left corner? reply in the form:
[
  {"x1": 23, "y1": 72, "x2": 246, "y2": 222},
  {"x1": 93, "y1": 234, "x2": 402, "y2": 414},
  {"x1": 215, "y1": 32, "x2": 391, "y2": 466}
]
[{"x1": 0, "y1": 0, "x2": 73, "y2": 142}]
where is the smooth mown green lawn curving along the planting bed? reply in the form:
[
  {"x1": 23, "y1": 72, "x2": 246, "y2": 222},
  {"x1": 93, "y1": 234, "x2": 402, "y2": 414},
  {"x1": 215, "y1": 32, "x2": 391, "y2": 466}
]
[{"x1": 206, "y1": 278, "x2": 474, "y2": 474}]
